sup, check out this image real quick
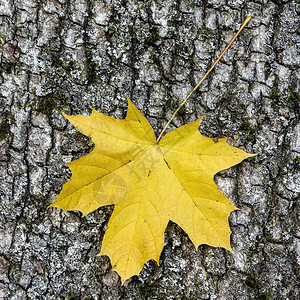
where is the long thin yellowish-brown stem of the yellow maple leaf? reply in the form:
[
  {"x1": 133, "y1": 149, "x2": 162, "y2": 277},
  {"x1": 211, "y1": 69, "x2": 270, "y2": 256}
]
[{"x1": 157, "y1": 14, "x2": 252, "y2": 143}]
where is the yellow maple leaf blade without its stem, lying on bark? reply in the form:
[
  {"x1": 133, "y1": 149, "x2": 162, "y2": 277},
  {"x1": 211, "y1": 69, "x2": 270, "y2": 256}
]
[{"x1": 50, "y1": 99, "x2": 253, "y2": 281}]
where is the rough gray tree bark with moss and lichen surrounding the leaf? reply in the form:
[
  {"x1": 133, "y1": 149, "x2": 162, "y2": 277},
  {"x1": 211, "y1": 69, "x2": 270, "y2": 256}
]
[{"x1": 0, "y1": 0, "x2": 300, "y2": 300}]
